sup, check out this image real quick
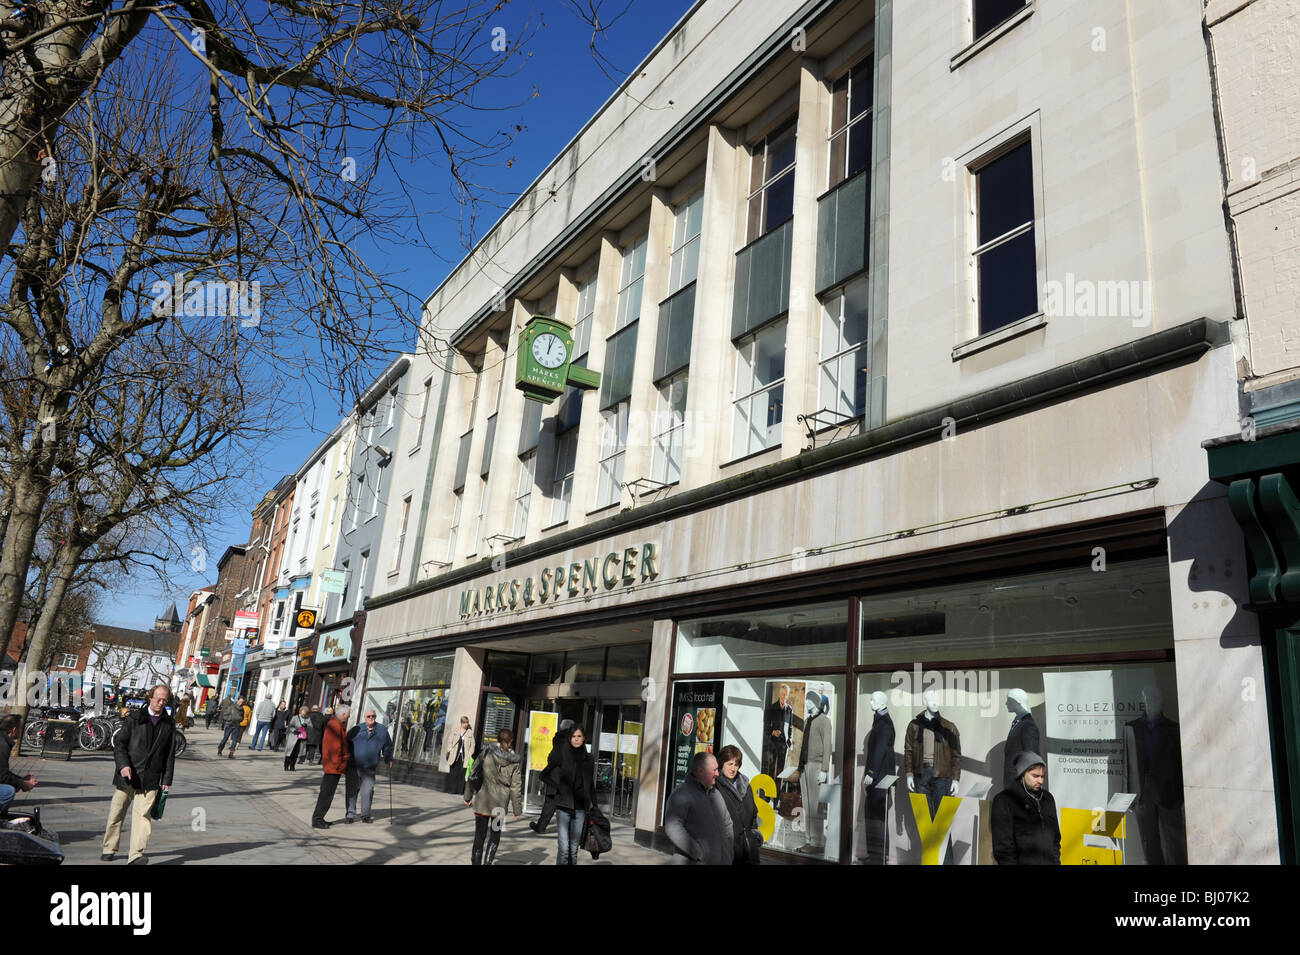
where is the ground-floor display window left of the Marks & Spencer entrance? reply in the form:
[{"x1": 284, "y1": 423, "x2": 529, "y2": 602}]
[{"x1": 363, "y1": 654, "x2": 455, "y2": 765}]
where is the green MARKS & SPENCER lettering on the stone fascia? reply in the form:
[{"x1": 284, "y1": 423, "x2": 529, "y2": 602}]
[{"x1": 460, "y1": 543, "x2": 659, "y2": 617}]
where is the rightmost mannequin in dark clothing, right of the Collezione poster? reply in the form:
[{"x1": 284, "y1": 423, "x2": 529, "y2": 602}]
[{"x1": 1125, "y1": 686, "x2": 1187, "y2": 865}]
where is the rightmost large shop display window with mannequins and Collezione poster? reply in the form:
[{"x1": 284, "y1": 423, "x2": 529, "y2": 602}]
[{"x1": 853, "y1": 560, "x2": 1187, "y2": 865}]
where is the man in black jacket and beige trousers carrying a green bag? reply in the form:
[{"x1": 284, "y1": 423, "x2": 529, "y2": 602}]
[{"x1": 100, "y1": 683, "x2": 176, "y2": 865}]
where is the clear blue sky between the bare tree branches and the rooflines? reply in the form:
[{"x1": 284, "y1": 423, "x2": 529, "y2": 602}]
[{"x1": 109, "y1": 0, "x2": 692, "y2": 629}]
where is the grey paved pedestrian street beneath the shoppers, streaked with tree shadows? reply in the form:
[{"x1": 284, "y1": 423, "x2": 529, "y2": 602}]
[{"x1": 12, "y1": 725, "x2": 668, "y2": 865}]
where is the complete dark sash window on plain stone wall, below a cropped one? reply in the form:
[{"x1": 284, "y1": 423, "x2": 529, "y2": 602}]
[{"x1": 970, "y1": 139, "x2": 1039, "y2": 334}]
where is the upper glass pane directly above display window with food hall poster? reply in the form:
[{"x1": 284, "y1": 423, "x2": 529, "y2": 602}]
[{"x1": 676, "y1": 600, "x2": 849, "y2": 673}]
